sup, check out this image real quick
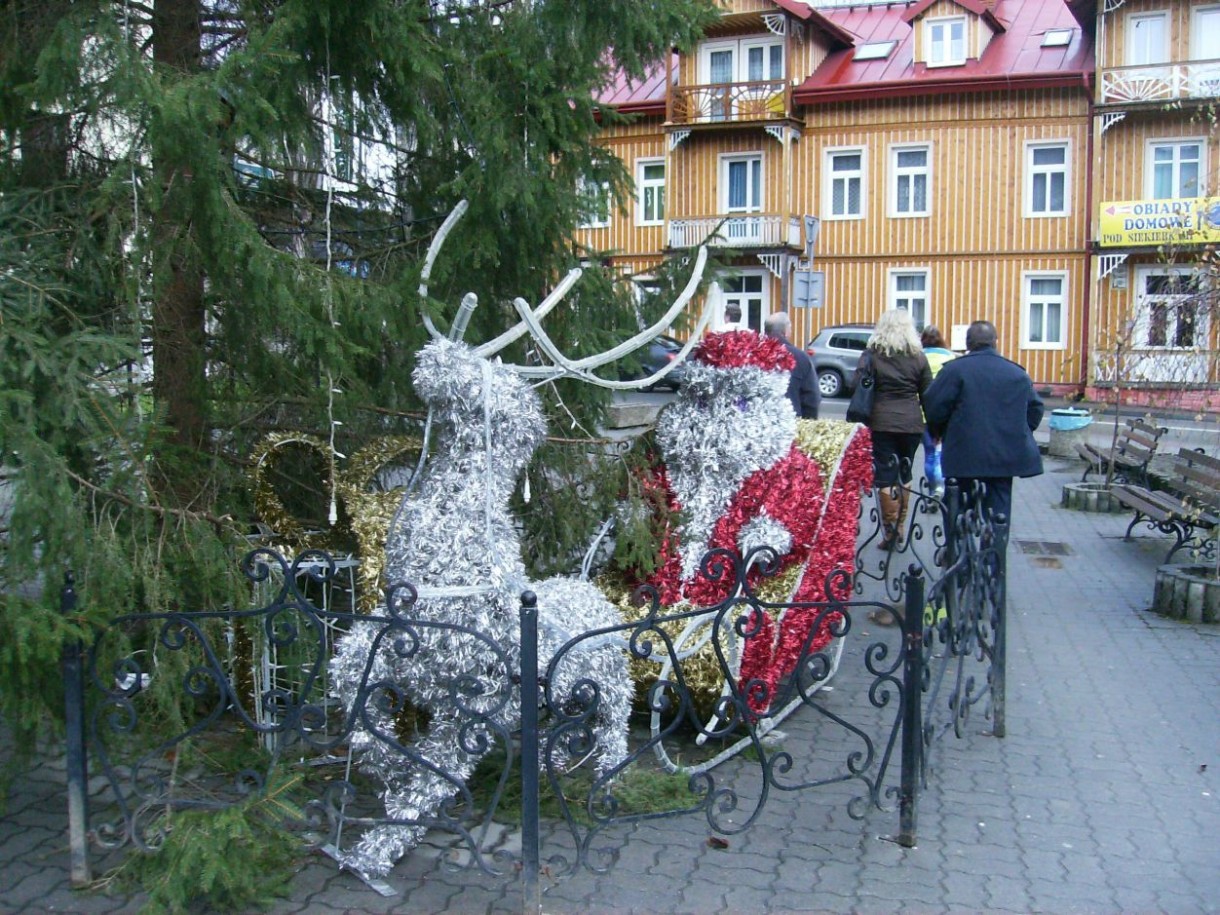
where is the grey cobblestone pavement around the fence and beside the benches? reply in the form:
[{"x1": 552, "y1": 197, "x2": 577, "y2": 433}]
[{"x1": 0, "y1": 446, "x2": 1220, "y2": 915}]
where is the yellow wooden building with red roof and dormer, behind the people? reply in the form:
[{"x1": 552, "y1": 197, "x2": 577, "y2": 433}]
[{"x1": 582, "y1": 0, "x2": 1220, "y2": 402}]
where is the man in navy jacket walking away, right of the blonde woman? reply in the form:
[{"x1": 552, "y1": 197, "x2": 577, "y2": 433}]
[{"x1": 924, "y1": 321, "x2": 1043, "y2": 529}]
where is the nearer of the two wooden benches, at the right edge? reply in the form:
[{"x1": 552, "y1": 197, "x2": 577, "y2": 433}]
[{"x1": 1111, "y1": 448, "x2": 1220, "y2": 564}]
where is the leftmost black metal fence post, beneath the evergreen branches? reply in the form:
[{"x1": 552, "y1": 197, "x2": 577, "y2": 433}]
[{"x1": 60, "y1": 571, "x2": 93, "y2": 887}]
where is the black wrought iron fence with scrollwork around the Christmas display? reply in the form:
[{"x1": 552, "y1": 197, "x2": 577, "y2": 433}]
[{"x1": 63, "y1": 475, "x2": 1007, "y2": 911}]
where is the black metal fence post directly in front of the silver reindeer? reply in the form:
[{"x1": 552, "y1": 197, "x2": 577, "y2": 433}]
[{"x1": 521, "y1": 590, "x2": 542, "y2": 915}]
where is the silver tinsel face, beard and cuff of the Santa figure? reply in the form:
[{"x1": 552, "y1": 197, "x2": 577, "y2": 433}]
[{"x1": 656, "y1": 356, "x2": 797, "y2": 581}]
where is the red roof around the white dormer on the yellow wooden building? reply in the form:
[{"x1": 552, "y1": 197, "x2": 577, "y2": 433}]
[{"x1": 793, "y1": 0, "x2": 1094, "y2": 105}]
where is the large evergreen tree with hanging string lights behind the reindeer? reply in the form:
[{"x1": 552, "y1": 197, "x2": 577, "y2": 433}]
[{"x1": 0, "y1": 0, "x2": 715, "y2": 746}]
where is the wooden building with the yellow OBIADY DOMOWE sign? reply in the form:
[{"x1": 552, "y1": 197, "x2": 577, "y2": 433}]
[{"x1": 1081, "y1": 0, "x2": 1220, "y2": 403}]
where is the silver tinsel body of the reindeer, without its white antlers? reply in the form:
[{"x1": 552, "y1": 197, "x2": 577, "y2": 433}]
[{"x1": 331, "y1": 339, "x2": 633, "y2": 876}]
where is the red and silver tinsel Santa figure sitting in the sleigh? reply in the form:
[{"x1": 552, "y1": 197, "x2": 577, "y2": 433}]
[{"x1": 648, "y1": 331, "x2": 869, "y2": 711}]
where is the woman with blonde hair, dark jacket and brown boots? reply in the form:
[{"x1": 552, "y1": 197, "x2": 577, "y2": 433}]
[{"x1": 854, "y1": 309, "x2": 932, "y2": 550}]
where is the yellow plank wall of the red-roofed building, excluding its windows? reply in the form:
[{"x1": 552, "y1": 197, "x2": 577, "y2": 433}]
[{"x1": 575, "y1": 88, "x2": 1091, "y2": 386}]
